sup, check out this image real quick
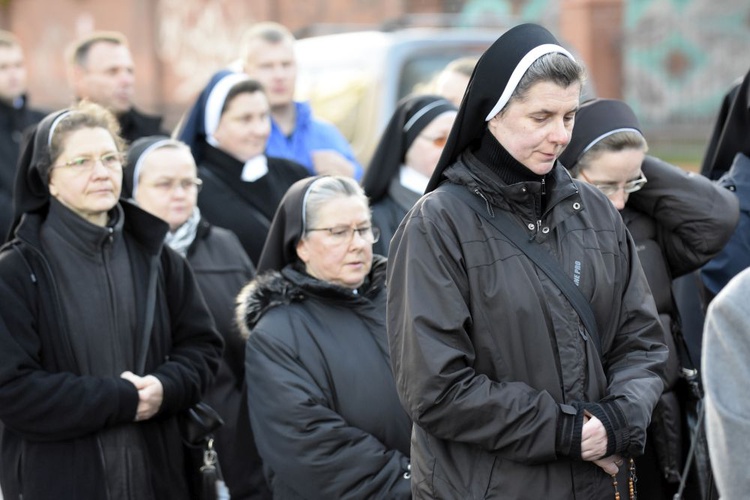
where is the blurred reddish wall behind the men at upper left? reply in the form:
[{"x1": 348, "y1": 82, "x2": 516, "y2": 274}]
[{"x1": 0, "y1": 0, "x2": 403, "y2": 131}]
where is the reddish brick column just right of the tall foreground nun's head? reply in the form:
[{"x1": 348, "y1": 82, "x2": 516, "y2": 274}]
[{"x1": 560, "y1": 0, "x2": 625, "y2": 99}]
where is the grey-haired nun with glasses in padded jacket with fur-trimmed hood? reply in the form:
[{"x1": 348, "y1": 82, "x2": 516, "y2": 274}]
[{"x1": 237, "y1": 176, "x2": 411, "y2": 499}]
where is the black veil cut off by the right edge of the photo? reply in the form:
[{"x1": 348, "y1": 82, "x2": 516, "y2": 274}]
[{"x1": 701, "y1": 71, "x2": 750, "y2": 179}]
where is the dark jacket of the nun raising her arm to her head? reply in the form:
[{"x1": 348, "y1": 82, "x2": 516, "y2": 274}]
[{"x1": 620, "y1": 156, "x2": 739, "y2": 482}]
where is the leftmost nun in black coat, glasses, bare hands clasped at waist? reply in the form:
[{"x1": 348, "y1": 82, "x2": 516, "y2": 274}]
[{"x1": 0, "y1": 101, "x2": 223, "y2": 500}]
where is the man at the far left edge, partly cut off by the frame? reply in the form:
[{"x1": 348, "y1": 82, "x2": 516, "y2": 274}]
[{"x1": 0, "y1": 30, "x2": 44, "y2": 243}]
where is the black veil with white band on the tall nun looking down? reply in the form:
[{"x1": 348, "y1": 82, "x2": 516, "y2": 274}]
[{"x1": 425, "y1": 24, "x2": 573, "y2": 193}]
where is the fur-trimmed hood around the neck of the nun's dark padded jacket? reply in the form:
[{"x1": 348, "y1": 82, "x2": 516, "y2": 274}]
[{"x1": 235, "y1": 255, "x2": 387, "y2": 339}]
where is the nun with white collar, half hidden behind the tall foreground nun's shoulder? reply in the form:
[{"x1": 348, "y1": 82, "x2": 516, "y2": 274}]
[{"x1": 362, "y1": 95, "x2": 457, "y2": 256}]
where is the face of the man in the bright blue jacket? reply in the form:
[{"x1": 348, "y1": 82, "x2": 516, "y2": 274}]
[{"x1": 244, "y1": 39, "x2": 297, "y2": 109}]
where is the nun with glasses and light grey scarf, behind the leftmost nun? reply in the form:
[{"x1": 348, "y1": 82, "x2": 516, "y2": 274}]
[{"x1": 123, "y1": 136, "x2": 269, "y2": 499}]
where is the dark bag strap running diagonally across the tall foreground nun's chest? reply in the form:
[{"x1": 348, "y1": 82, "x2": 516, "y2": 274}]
[{"x1": 437, "y1": 182, "x2": 603, "y2": 359}]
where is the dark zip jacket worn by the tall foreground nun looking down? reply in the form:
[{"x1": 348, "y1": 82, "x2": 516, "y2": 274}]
[{"x1": 388, "y1": 153, "x2": 667, "y2": 500}]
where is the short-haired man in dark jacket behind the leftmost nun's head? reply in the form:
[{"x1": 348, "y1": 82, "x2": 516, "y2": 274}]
[{"x1": 68, "y1": 31, "x2": 169, "y2": 143}]
